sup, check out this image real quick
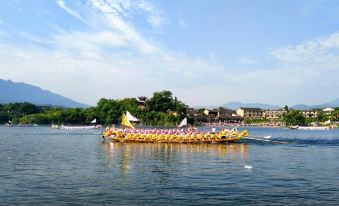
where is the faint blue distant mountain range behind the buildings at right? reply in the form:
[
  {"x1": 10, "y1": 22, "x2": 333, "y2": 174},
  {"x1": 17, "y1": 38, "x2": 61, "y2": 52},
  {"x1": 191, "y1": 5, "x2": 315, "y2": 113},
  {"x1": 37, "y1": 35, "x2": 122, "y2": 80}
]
[{"x1": 195, "y1": 98, "x2": 339, "y2": 110}]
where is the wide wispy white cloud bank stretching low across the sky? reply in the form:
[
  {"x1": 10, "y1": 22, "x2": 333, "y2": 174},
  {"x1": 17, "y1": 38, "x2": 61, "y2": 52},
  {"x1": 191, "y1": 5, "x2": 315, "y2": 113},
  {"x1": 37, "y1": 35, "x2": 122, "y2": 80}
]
[{"x1": 0, "y1": 0, "x2": 339, "y2": 105}]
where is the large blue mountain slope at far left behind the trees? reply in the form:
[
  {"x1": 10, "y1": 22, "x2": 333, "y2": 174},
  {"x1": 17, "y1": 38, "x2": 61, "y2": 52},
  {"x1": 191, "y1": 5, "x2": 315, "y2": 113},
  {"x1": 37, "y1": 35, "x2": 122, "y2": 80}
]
[{"x1": 0, "y1": 79, "x2": 88, "y2": 107}]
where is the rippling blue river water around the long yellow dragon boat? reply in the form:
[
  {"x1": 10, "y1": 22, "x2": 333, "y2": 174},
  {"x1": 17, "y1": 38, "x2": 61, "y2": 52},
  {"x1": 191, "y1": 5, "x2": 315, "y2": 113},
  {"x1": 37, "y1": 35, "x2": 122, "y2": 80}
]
[{"x1": 0, "y1": 127, "x2": 339, "y2": 205}]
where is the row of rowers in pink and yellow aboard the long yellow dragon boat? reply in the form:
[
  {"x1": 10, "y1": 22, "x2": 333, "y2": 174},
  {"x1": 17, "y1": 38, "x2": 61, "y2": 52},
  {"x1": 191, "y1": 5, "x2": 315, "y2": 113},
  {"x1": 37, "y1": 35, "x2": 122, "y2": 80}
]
[{"x1": 104, "y1": 127, "x2": 247, "y2": 138}]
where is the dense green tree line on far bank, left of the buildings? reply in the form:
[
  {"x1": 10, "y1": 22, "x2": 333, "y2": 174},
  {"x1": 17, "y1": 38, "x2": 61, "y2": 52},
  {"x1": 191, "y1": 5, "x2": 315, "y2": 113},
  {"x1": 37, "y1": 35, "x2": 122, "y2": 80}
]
[{"x1": 0, "y1": 91, "x2": 194, "y2": 126}]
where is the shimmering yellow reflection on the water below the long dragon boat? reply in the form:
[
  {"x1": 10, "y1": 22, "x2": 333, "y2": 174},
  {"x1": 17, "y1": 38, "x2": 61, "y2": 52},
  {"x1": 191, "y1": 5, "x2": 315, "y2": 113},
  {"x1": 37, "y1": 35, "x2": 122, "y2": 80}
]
[{"x1": 103, "y1": 142, "x2": 249, "y2": 174}]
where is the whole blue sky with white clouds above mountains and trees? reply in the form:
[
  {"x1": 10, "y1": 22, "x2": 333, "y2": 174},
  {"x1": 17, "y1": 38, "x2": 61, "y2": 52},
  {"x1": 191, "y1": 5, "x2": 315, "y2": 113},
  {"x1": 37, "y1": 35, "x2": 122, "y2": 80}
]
[{"x1": 0, "y1": 0, "x2": 339, "y2": 106}]
